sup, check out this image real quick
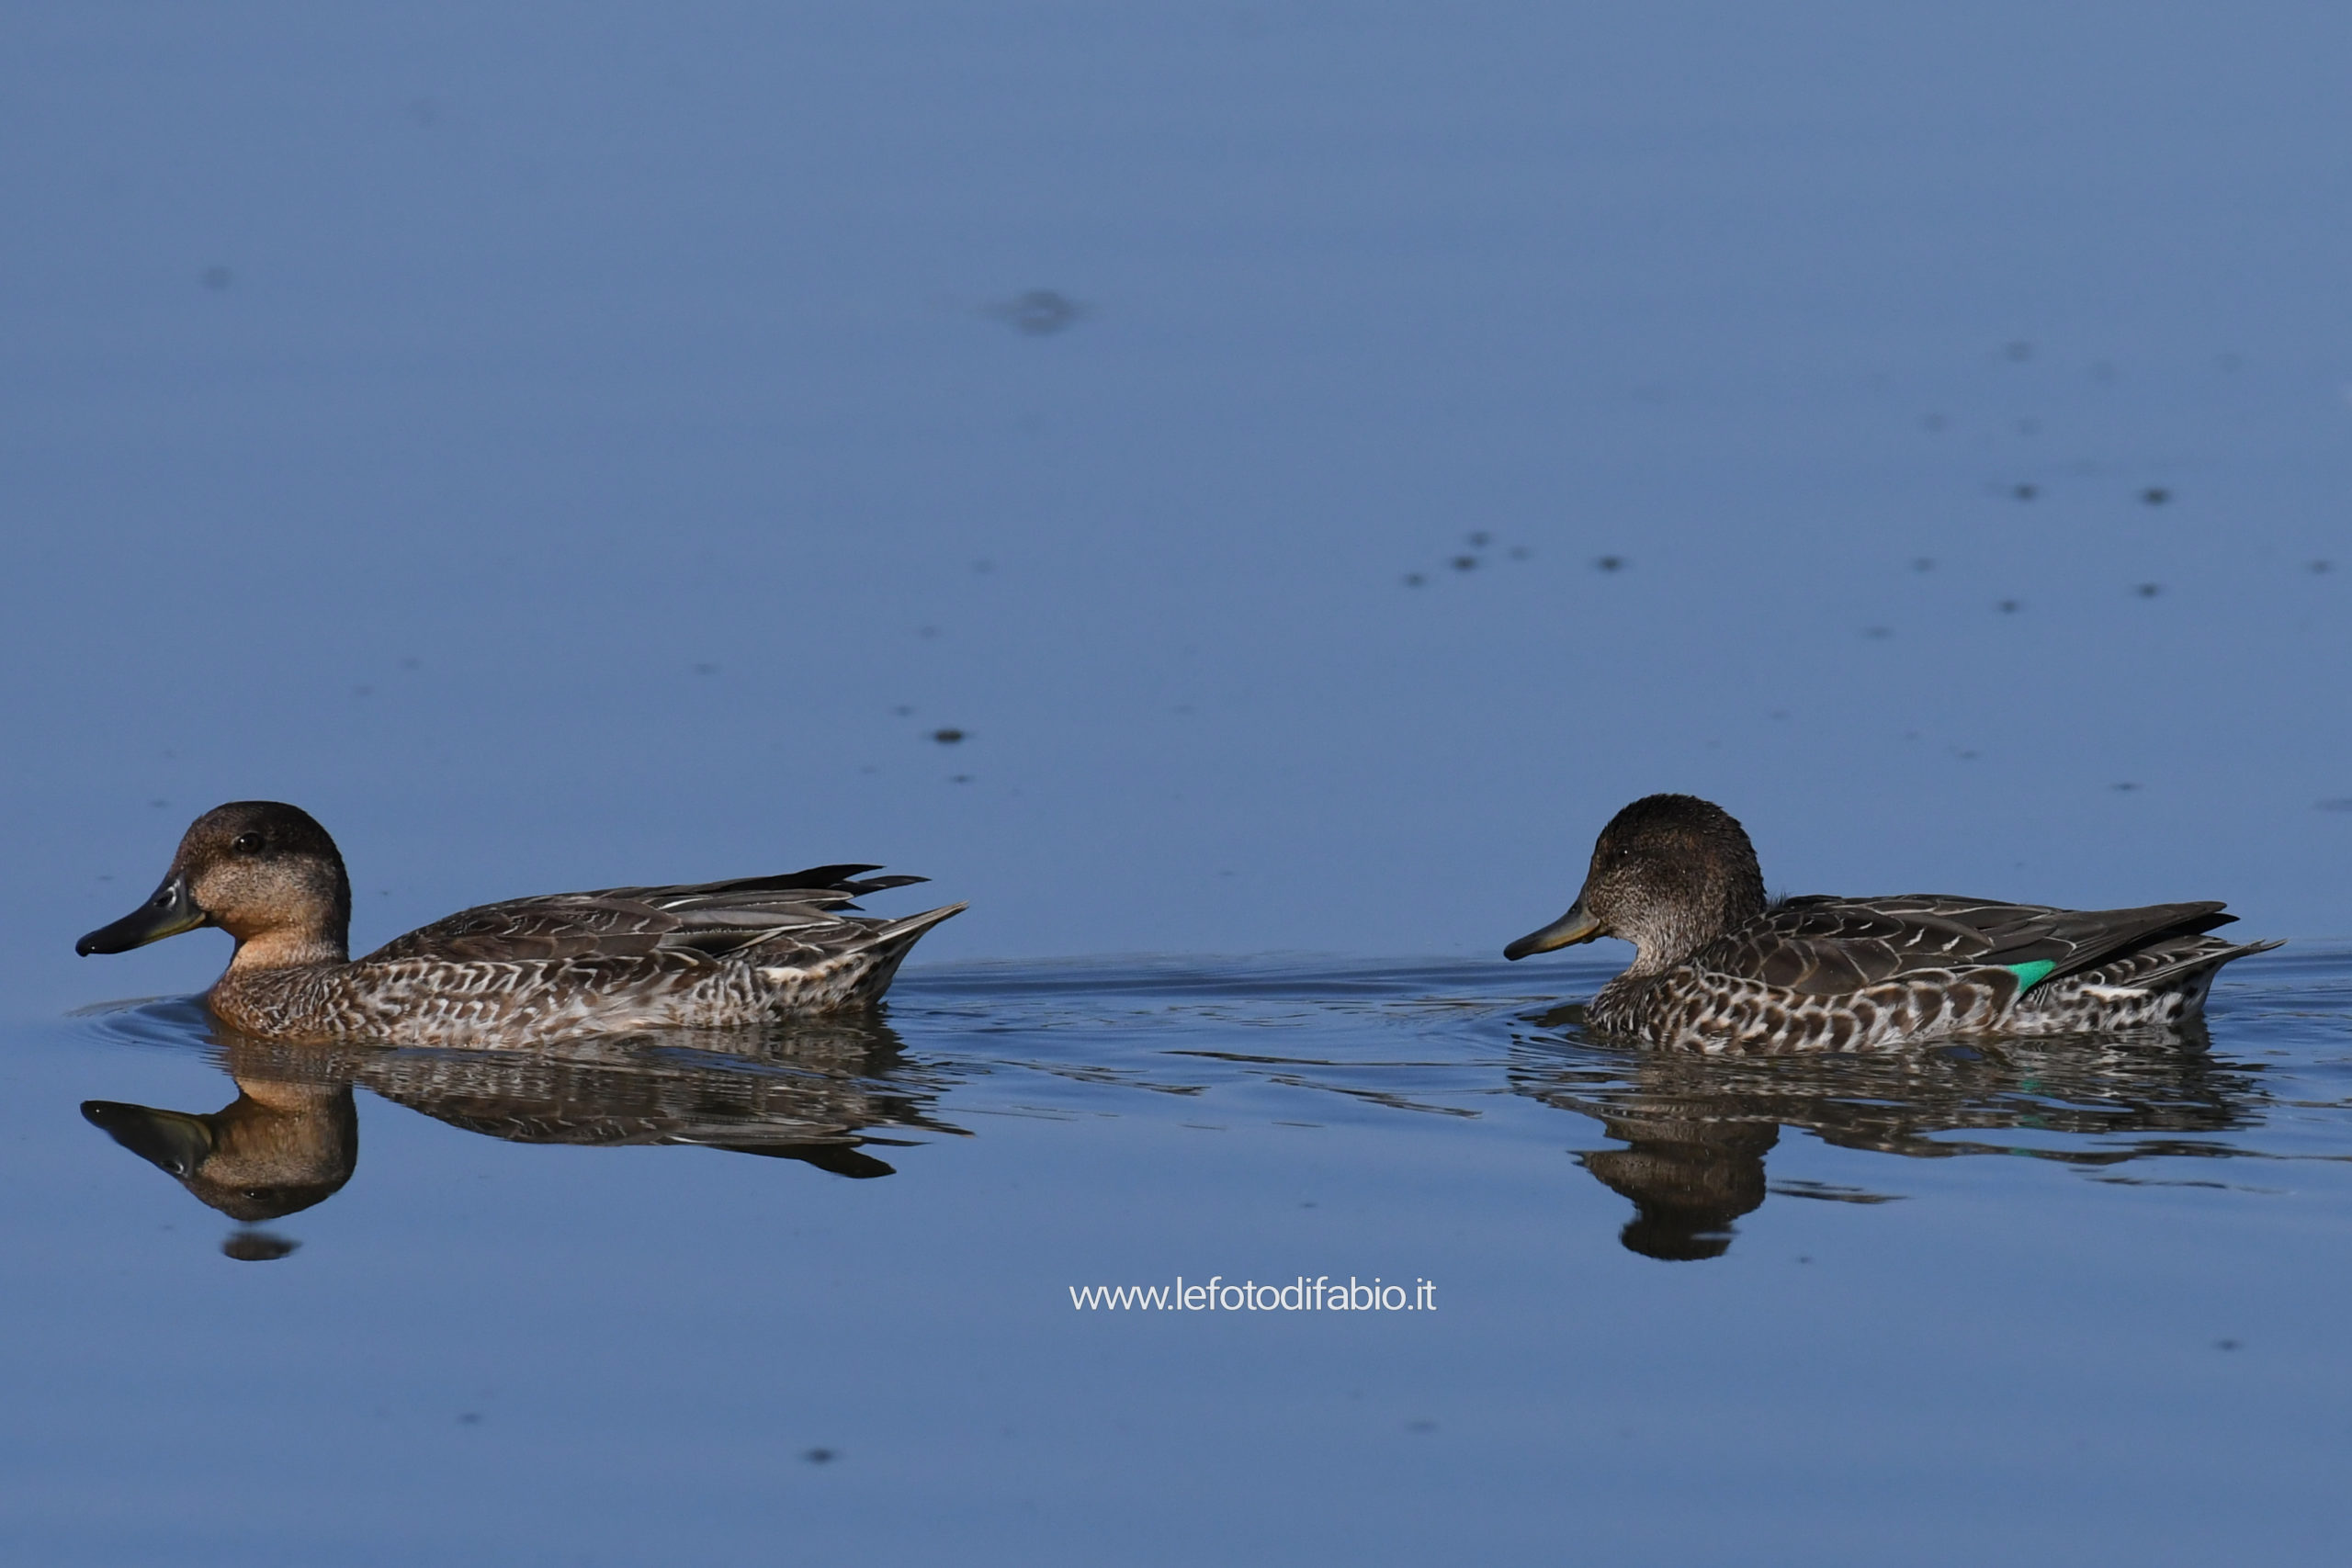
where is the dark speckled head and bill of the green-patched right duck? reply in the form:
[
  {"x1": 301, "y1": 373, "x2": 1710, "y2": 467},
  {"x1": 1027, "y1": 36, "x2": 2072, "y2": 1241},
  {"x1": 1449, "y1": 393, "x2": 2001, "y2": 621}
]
[{"x1": 1503, "y1": 795, "x2": 1764, "y2": 974}]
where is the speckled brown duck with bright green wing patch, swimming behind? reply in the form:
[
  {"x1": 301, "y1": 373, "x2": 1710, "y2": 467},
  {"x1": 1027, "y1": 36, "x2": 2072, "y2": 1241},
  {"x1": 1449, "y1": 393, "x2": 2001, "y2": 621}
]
[{"x1": 1503, "y1": 795, "x2": 2279, "y2": 1054}]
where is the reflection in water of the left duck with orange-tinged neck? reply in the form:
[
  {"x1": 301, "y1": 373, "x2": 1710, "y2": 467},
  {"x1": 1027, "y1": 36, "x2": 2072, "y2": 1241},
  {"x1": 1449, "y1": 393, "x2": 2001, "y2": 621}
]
[{"x1": 83, "y1": 1004, "x2": 965, "y2": 1258}]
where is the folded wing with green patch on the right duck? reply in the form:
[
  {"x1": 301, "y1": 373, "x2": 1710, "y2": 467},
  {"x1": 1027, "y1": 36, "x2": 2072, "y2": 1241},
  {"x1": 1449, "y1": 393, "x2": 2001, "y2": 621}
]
[{"x1": 1696, "y1": 894, "x2": 2237, "y2": 997}]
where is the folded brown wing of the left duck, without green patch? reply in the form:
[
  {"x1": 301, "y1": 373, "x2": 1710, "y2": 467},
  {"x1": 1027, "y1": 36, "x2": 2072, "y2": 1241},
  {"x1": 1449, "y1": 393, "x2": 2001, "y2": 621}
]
[{"x1": 360, "y1": 865, "x2": 922, "y2": 964}]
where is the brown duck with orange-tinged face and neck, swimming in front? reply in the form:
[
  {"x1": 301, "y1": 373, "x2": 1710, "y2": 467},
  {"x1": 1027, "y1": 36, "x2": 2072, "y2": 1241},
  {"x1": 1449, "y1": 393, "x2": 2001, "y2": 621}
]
[{"x1": 73, "y1": 799, "x2": 967, "y2": 1048}]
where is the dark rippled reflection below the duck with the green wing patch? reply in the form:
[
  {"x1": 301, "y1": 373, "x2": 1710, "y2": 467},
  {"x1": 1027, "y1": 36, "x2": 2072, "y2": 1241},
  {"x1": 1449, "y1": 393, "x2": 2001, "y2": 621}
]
[{"x1": 1510, "y1": 1006, "x2": 2265, "y2": 1262}]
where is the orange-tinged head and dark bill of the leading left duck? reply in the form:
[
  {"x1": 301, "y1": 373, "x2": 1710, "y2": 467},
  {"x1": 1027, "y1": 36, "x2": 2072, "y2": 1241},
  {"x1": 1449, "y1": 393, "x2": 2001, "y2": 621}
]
[{"x1": 73, "y1": 799, "x2": 350, "y2": 966}]
